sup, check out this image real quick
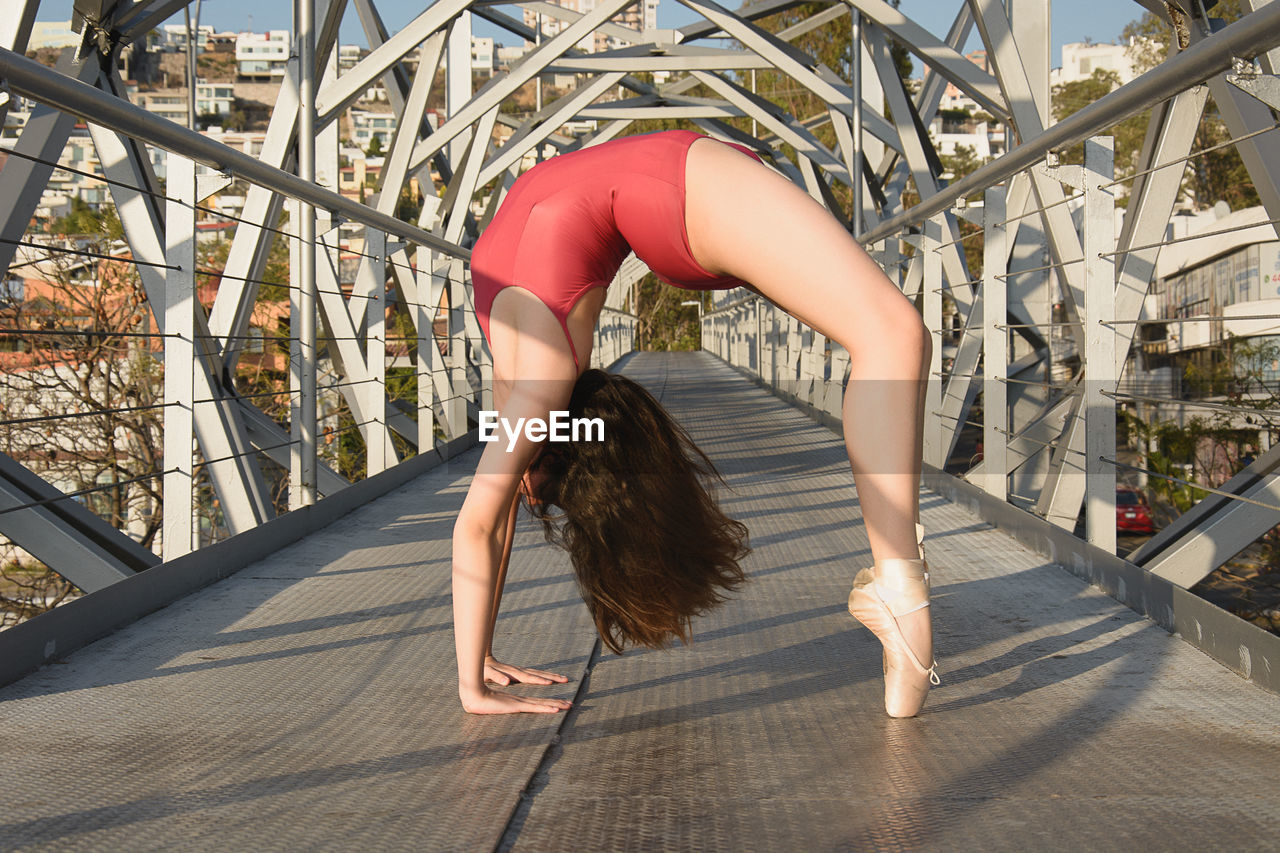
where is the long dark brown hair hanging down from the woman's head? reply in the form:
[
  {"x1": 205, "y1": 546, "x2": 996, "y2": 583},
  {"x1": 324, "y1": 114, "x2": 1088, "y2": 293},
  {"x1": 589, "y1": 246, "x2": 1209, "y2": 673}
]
[{"x1": 526, "y1": 370, "x2": 750, "y2": 653}]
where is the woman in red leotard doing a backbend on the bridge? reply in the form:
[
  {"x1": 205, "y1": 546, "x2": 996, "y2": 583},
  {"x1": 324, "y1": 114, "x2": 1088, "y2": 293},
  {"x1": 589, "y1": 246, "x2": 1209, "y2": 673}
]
[{"x1": 453, "y1": 131, "x2": 937, "y2": 716}]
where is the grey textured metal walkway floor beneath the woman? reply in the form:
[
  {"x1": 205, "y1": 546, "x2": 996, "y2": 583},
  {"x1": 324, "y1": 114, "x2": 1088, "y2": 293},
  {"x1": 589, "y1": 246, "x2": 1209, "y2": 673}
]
[{"x1": 0, "y1": 353, "x2": 1280, "y2": 850}]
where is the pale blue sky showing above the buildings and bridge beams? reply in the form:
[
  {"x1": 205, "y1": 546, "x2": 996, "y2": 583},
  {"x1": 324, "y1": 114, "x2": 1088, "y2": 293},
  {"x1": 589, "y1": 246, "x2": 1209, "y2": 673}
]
[{"x1": 38, "y1": 0, "x2": 1143, "y2": 67}]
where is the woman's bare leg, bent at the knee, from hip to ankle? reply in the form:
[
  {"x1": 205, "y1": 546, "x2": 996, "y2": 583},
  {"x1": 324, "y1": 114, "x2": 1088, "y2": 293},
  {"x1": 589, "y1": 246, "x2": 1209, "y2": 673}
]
[{"x1": 686, "y1": 142, "x2": 933, "y2": 706}]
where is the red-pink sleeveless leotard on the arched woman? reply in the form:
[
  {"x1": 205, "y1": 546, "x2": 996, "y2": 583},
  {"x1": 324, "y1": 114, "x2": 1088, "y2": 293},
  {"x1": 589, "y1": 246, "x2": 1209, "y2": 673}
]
[{"x1": 471, "y1": 131, "x2": 760, "y2": 364}]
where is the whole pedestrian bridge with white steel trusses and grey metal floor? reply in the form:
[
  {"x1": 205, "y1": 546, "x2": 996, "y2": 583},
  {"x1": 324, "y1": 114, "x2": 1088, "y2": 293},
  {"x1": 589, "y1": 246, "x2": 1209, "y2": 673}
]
[{"x1": 0, "y1": 0, "x2": 1280, "y2": 850}]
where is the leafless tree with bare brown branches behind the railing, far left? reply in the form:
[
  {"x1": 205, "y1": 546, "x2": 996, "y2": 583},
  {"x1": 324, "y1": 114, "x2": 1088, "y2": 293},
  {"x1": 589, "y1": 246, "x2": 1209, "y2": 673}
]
[{"x1": 0, "y1": 219, "x2": 164, "y2": 621}]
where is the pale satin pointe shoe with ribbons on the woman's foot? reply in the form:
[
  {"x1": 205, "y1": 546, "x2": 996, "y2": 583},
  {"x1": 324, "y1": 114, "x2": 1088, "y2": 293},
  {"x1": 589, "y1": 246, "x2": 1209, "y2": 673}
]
[{"x1": 849, "y1": 525, "x2": 941, "y2": 717}]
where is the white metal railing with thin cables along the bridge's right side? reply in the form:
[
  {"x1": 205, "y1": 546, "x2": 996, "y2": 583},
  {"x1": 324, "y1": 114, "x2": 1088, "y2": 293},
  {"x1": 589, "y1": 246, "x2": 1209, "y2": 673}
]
[{"x1": 703, "y1": 4, "x2": 1280, "y2": 604}]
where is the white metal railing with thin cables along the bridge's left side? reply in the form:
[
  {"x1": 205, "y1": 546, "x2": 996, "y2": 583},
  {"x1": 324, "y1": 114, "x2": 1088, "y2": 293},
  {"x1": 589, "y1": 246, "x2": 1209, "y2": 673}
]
[{"x1": 0, "y1": 38, "x2": 635, "y2": 617}]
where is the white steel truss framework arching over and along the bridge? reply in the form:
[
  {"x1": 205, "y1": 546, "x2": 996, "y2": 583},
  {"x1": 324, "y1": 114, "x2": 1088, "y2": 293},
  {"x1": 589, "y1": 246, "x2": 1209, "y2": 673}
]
[{"x1": 0, "y1": 0, "x2": 1280, "y2": 601}]
